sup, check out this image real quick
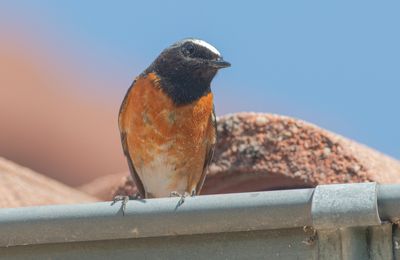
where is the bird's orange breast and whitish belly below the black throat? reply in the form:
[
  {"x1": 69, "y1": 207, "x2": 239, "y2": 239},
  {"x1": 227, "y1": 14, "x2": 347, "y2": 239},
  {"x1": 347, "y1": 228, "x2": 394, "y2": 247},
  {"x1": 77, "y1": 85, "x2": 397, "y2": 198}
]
[{"x1": 119, "y1": 73, "x2": 215, "y2": 197}]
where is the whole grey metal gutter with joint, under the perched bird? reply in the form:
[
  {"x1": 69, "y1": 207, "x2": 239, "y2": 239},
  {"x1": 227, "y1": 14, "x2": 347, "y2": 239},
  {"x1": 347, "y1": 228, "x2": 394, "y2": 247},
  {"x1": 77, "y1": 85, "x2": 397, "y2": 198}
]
[{"x1": 0, "y1": 183, "x2": 400, "y2": 259}]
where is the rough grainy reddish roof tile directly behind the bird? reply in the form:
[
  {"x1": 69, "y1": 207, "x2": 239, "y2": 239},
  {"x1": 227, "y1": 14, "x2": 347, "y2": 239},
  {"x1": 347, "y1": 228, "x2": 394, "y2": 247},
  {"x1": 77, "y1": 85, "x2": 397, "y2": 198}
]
[{"x1": 79, "y1": 113, "x2": 400, "y2": 199}]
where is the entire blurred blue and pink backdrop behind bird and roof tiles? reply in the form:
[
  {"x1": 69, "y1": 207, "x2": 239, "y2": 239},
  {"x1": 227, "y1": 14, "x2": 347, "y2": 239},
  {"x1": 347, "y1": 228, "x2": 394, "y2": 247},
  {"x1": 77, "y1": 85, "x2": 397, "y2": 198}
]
[{"x1": 0, "y1": 0, "x2": 400, "y2": 186}]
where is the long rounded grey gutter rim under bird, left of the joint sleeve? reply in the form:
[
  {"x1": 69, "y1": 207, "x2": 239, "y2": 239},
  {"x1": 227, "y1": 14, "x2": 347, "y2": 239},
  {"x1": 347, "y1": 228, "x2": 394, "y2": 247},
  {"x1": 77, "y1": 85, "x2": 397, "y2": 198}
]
[{"x1": 0, "y1": 189, "x2": 313, "y2": 247}]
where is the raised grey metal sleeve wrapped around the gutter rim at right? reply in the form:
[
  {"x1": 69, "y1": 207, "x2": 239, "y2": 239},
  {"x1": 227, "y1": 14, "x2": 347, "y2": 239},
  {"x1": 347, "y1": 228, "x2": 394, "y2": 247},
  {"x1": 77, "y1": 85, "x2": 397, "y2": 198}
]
[{"x1": 311, "y1": 182, "x2": 381, "y2": 229}]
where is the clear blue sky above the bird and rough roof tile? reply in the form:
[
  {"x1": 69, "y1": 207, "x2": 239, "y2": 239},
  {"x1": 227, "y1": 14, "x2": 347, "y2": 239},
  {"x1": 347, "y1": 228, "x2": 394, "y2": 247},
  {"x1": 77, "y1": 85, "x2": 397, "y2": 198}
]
[{"x1": 0, "y1": 1, "x2": 400, "y2": 158}]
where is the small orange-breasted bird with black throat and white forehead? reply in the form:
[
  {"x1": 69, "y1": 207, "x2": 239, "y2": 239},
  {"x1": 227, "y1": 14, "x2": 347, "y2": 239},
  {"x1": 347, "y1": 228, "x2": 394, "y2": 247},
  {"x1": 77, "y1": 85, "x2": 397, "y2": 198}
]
[{"x1": 116, "y1": 38, "x2": 230, "y2": 207}]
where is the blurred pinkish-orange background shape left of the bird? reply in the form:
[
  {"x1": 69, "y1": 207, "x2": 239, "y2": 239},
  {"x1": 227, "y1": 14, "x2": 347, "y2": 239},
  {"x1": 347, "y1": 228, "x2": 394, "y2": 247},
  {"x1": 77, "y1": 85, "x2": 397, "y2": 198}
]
[{"x1": 0, "y1": 28, "x2": 126, "y2": 185}]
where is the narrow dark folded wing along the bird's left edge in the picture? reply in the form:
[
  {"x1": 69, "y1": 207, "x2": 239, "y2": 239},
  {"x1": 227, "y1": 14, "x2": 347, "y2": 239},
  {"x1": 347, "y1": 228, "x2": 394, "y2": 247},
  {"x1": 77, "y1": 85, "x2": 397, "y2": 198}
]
[{"x1": 118, "y1": 80, "x2": 146, "y2": 198}]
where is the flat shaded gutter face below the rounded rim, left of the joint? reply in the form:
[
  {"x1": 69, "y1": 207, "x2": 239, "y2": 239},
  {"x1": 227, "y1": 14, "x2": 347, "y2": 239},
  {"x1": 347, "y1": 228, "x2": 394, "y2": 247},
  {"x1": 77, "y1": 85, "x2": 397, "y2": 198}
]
[{"x1": 0, "y1": 229, "x2": 318, "y2": 260}]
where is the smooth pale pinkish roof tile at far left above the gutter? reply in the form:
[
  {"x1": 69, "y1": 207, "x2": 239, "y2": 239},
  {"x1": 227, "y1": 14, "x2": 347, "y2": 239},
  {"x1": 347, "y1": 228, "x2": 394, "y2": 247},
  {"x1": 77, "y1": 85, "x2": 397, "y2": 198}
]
[{"x1": 0, "y1": 157, "x2": 98, "y2": 208}]
